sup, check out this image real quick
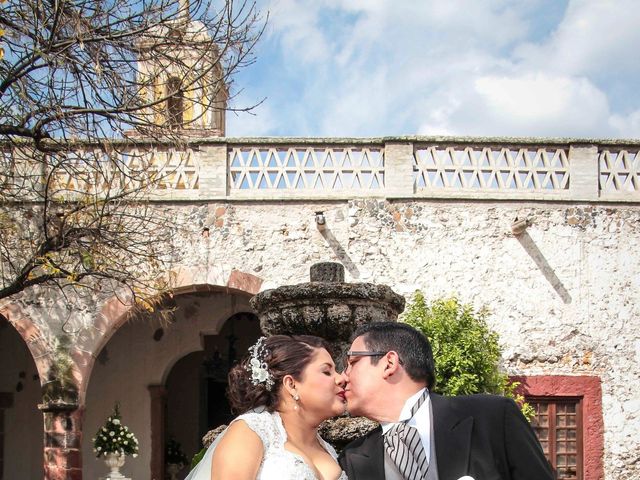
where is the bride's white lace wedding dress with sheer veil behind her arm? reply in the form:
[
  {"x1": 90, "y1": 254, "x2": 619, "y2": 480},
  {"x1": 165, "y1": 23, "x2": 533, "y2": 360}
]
[{"x1": 185, "y1": 410, "x2": 347, "y2": 480}]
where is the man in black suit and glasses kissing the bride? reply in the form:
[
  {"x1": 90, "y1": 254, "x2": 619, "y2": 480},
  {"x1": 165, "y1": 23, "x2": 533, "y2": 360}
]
[{"x1": 339, "y1": 322, "x2": 553, "y2": 480}]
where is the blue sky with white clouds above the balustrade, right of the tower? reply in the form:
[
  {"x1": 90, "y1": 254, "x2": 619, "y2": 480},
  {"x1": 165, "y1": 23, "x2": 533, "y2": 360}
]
[{"x1": 227, "y1": 0, "x2": 640, "y2": 138}]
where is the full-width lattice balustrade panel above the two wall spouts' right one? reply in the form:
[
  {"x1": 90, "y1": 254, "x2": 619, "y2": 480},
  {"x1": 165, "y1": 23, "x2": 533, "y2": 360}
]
[{"x1": 414, "y1": 146, "x2": 569, "y2": 192}]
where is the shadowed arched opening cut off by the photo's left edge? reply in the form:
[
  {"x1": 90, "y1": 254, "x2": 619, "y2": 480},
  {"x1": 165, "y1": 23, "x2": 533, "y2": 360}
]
[{"x1": 0, "y1": 315, "x2": 43, "y2": 480}]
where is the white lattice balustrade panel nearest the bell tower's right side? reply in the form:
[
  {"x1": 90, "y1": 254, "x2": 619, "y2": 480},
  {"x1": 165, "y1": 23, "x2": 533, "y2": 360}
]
[{"x1": 229, "y1": 147, "x2": 384, "y2": 190}]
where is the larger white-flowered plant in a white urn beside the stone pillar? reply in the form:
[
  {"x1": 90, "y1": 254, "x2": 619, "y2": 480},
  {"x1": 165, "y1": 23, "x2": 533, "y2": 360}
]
[{"x1": 93, "y1": 403, "x2": 138, "y2": 479}]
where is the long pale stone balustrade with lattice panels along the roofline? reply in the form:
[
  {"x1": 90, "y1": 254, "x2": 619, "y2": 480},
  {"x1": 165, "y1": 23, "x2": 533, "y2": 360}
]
[{"x1": 0, "y1": 137, "x2": 640, "y2": 203}]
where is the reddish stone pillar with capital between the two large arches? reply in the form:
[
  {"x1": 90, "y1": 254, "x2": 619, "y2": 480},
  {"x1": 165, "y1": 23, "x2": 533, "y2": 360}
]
[{"x1": 38, "y1": 403, "x2": 84, "y2": 480}]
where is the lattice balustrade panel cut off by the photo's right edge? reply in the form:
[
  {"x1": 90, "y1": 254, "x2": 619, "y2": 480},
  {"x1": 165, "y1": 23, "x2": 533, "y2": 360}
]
[{"x1": 598, "y1": 150, "x2": 640, "y2": 193}]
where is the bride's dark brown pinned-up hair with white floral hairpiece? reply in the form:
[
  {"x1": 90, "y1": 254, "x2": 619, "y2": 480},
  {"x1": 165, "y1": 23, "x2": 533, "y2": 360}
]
[{"x1": 227, "y1": 335, "x2": 330, "y2": 414}]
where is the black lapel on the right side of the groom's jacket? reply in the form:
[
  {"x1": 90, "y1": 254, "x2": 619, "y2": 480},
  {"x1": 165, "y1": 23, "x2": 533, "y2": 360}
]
[{"x1": 429, "y1": 394, "x2": 473, "y2": 480}]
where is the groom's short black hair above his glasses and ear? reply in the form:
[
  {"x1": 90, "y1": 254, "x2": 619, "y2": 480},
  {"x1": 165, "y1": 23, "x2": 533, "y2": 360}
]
[{"x1": 351, "y1": 322, "x2": 436, "y2": 390}]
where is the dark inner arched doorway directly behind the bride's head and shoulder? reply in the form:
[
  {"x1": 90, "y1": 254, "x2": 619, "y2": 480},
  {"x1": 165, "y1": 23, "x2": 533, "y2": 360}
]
[{"x1": 164, "y1": 312, "x2": 260, "y2": 478}]
